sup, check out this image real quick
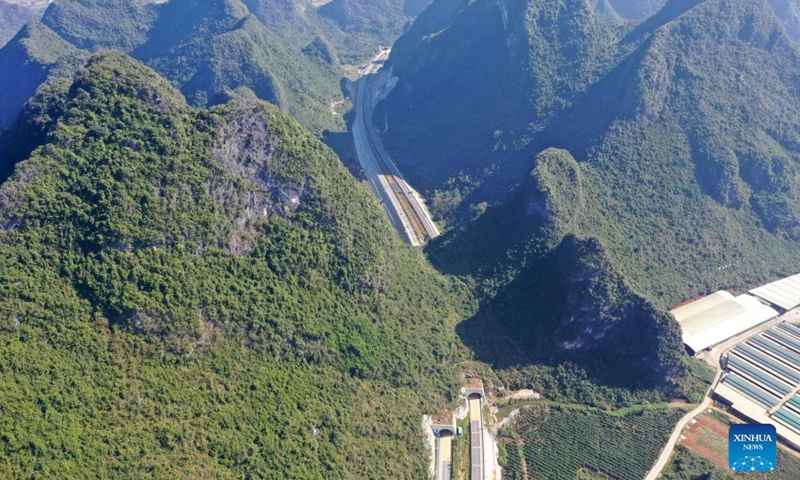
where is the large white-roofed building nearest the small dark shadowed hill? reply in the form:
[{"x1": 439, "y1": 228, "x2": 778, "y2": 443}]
[{"x1": 670, "y1": 291, "x2": 778, "y2": 352}]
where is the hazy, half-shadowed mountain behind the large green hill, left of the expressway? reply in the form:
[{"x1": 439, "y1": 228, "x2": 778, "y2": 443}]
[{"x1": 133, "y1": 0, "x2": 342, "y2": 133}]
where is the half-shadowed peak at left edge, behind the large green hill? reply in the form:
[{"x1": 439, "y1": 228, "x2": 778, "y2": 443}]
[{"x1": 0, "y1": 21, "x2": 86, "y2": 132}]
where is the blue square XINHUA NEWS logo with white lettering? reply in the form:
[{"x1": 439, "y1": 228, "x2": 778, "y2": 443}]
[{"x1": 728, "y1": 424, "x2": 778, "y2": 472}]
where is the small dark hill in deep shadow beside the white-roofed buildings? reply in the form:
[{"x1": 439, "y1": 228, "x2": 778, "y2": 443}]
[{"x1": 457, "y1": 235, "x2": 687, "y2": 396}]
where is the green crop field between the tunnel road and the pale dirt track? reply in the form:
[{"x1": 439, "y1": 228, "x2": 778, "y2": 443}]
[{"x1": 500, "y1": 407, "x2": 686, "y2": 480}]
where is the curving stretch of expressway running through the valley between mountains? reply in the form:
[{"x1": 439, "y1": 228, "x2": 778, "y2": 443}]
[{"x1": 353, "y1": 50, "x2": 439, "y2": 247}]
